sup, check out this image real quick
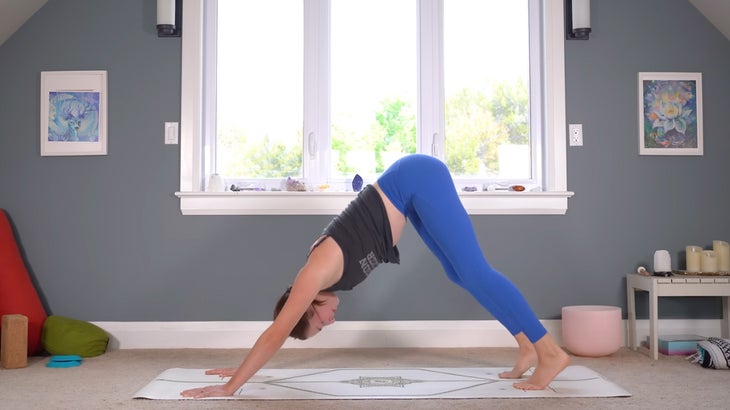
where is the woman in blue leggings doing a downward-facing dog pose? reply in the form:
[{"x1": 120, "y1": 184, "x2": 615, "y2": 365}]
[{"x1": 182, "y1": 154, "x2": 569, "y2": 398}]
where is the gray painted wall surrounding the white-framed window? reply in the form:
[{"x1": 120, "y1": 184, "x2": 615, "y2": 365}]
[{"x1": 0, "y1": 0, "x2": 730, "y2": 321}]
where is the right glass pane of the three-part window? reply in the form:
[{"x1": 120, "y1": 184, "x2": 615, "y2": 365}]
[{"x1": 444, "y1": 0, "x2": 531, "y2": 179}]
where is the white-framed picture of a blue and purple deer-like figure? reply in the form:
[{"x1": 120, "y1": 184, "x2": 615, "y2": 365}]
[{"x1": 40, "y1": 71, "x2": 107, "y2": 156}]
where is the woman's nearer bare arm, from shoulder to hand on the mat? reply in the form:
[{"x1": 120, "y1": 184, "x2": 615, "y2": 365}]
[{"x1": 181, "y1": 238, "x2": 342, "y2": 398}]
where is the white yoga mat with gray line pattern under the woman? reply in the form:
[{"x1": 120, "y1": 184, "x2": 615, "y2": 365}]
[{"x1": 134, "y1": 366, "x2": 631, "y2": 400}]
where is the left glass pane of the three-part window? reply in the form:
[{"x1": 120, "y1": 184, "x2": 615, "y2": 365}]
[{"x1": 217, "y1": 0, "x2": 303, "y2": 179}]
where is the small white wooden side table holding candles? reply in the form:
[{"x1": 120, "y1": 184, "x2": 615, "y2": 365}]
[{"x1": 626, "y1": 273, "x2": 730, "y2": 360}]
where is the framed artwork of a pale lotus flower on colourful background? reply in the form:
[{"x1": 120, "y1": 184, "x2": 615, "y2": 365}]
[{"x1": 639, "y1": 73, "x2": 703, "y2": 155}]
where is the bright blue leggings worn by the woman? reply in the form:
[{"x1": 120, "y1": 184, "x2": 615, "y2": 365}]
[{"x1": 378, "y1": 154, "x2": 547, "y2": 343}]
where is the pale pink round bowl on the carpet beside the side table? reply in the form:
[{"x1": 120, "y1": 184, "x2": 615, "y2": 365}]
[{"x1": 562, "y1": 305, "x2": 623, "y2": 357}]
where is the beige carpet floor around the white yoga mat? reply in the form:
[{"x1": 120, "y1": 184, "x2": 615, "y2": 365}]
[{"x1": 0, "y1": 348, "x2": 730, "y2": 410}]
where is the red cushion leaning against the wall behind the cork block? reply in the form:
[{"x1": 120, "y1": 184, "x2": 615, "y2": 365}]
[{"x1": 0, "y1": 209, "x2": 47, "y2": 355}]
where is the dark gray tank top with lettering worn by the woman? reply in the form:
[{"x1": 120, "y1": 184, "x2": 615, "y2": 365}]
[{"x1": 310, "y1": 185, "x2": 400, "y2": 291}]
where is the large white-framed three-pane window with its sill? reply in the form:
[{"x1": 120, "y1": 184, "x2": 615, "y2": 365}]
[{"x1": 177, "y1": 0, "x2": 572, "y2": 214}]
